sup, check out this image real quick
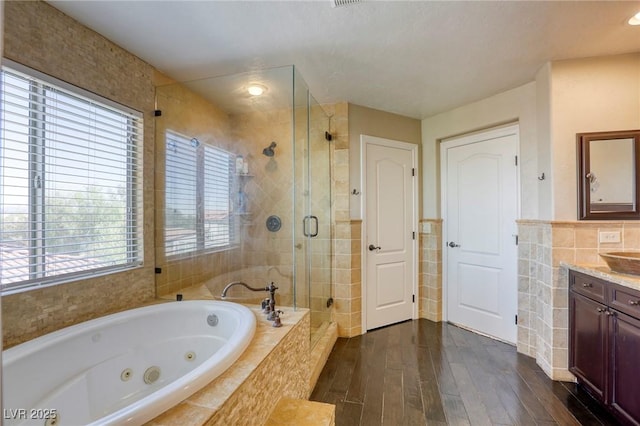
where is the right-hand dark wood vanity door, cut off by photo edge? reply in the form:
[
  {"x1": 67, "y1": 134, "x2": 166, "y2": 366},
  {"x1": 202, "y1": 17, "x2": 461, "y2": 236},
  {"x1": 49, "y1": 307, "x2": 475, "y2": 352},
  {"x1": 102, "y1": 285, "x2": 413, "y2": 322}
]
[{"x1": 609, "y1": 311, "x2": 640, "y2": 425}]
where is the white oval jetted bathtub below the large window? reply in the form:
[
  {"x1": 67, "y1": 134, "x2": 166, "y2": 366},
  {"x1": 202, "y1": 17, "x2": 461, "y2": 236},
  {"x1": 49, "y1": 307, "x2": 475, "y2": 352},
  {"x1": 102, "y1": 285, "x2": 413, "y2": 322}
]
[{"x1": 2, "y1": 300, "x2": 256, "y2": 426}]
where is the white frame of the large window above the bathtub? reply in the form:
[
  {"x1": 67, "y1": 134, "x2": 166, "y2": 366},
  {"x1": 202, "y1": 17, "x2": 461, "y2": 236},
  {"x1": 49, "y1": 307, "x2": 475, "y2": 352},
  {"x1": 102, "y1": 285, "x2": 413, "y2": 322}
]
[{"x1": 0, "y1": 58, "x2": 144, "y2": 295}]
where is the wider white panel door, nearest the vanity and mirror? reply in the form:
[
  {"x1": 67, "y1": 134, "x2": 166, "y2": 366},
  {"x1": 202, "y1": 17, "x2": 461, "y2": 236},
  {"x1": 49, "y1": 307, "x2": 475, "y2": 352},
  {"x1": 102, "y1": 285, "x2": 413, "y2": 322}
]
[{"x1": 442, "y1": 126, "x2": 518, "y2": 343}]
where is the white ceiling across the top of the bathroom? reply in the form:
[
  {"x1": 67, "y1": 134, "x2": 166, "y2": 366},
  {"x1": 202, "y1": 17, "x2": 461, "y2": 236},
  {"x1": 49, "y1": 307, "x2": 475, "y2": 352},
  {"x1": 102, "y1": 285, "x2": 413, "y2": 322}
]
[{"x1": 49, "y1": 0, "x2": 640, "y2": 118}]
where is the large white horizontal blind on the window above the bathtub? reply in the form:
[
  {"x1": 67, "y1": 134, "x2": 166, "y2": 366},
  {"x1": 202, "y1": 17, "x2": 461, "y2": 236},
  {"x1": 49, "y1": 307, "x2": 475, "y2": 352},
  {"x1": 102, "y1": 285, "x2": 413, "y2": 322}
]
[{"x1": 0, "y1": 68, "x2": 142, "y2": 291}]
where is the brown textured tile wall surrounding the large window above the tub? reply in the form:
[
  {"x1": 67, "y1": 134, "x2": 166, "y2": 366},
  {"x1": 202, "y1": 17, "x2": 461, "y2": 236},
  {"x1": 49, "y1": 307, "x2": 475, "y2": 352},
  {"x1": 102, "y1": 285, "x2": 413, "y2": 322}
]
[{"x1": 2, "y1": 1, "x2": 155, "y2": 347}]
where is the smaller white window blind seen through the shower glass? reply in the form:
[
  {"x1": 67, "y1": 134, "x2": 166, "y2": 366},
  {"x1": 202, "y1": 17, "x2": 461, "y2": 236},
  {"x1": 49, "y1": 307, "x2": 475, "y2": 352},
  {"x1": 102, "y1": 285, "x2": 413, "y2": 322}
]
[{"x1": 164, "y1": 131, "x2": 237, "y2": 257}]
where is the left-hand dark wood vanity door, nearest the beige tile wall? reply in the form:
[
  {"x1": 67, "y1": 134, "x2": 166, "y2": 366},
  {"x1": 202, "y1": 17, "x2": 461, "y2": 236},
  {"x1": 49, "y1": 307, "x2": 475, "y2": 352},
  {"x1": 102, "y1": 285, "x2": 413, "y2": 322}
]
[{"x1": 569, "y1": 291, "x2": 608, "y2": 402}]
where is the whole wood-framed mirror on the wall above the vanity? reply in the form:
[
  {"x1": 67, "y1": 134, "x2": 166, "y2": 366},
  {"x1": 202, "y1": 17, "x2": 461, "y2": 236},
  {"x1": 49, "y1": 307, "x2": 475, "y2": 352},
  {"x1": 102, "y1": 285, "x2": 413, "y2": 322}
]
[{"x1": 576, "y1": 130, "x2": 640, "y2": 220}]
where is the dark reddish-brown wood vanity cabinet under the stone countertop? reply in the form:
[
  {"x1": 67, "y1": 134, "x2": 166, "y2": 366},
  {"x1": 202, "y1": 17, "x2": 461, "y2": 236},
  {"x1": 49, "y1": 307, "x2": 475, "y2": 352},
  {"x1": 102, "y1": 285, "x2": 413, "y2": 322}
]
[{"x1": 569, "y1": 270, "x2": 640, "y2": 425}]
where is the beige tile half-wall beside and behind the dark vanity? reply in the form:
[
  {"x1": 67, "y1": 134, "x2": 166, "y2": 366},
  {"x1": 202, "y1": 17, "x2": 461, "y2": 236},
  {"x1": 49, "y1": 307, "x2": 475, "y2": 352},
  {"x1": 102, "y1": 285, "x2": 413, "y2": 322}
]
[{"x1": 518, "y1": 221, "x2": 640, "y2": 380}]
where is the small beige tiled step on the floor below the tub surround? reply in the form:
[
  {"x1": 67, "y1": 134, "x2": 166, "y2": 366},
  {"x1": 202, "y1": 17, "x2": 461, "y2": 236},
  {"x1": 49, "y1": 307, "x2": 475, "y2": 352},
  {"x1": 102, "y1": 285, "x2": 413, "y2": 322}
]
[{"x1": 265, "y1": 398, "x2": 336, "y2": 426}]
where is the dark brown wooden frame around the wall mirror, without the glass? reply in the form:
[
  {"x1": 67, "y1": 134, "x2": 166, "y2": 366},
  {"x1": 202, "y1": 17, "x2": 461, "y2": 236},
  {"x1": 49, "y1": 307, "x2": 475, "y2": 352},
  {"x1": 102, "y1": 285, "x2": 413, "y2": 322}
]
[{"x1": 576, "y1": 130, "x2": 640, "y2": 220}]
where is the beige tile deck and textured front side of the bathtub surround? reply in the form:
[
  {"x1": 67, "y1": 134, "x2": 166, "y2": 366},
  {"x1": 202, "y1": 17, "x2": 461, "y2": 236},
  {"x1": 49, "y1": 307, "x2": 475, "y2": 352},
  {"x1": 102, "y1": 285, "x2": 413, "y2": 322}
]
[{"x1": 147, "y1": 286, "x2": 311, "y2": 426}]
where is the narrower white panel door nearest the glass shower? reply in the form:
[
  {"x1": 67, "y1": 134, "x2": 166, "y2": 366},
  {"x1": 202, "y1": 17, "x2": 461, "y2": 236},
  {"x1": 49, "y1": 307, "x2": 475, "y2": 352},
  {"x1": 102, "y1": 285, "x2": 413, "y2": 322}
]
[{"x1": 362, "y1": 136, "x2": 417, "y2": 330}]
